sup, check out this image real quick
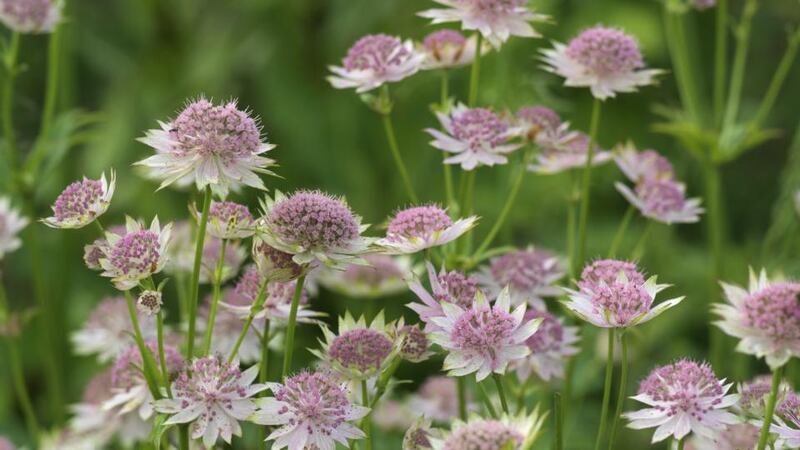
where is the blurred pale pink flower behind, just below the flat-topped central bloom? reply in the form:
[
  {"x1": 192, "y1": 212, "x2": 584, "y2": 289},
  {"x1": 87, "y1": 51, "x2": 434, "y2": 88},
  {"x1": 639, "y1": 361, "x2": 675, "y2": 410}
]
[{"x1": 319, "y1": 254, "x2": 411, "y2": 299}]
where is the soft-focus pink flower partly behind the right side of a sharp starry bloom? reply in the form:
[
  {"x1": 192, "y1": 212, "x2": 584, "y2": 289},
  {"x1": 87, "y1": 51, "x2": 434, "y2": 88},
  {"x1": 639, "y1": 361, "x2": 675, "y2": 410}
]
[{"x1": 514, "y1": 309, "x2": 580, "y2": 381}]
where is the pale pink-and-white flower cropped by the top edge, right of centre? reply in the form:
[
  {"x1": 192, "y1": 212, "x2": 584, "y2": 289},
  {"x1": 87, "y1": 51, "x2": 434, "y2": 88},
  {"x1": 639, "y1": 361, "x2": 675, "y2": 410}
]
[{"x1": 419, "y1": 0, "x2": 548, "y2": 48}]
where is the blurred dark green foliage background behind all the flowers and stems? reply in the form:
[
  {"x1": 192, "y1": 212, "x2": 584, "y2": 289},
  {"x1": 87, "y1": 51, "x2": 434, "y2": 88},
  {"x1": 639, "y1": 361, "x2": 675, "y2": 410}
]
[{"x1": 0, "y1": 0, "x2": 800, "y2": 450}]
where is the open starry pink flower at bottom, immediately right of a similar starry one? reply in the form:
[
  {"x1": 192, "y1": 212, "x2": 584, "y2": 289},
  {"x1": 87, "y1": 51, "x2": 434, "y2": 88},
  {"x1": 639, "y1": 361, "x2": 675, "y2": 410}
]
[{"x1": 250, "y1": 372, "x2": 369, "y2": 450}]
